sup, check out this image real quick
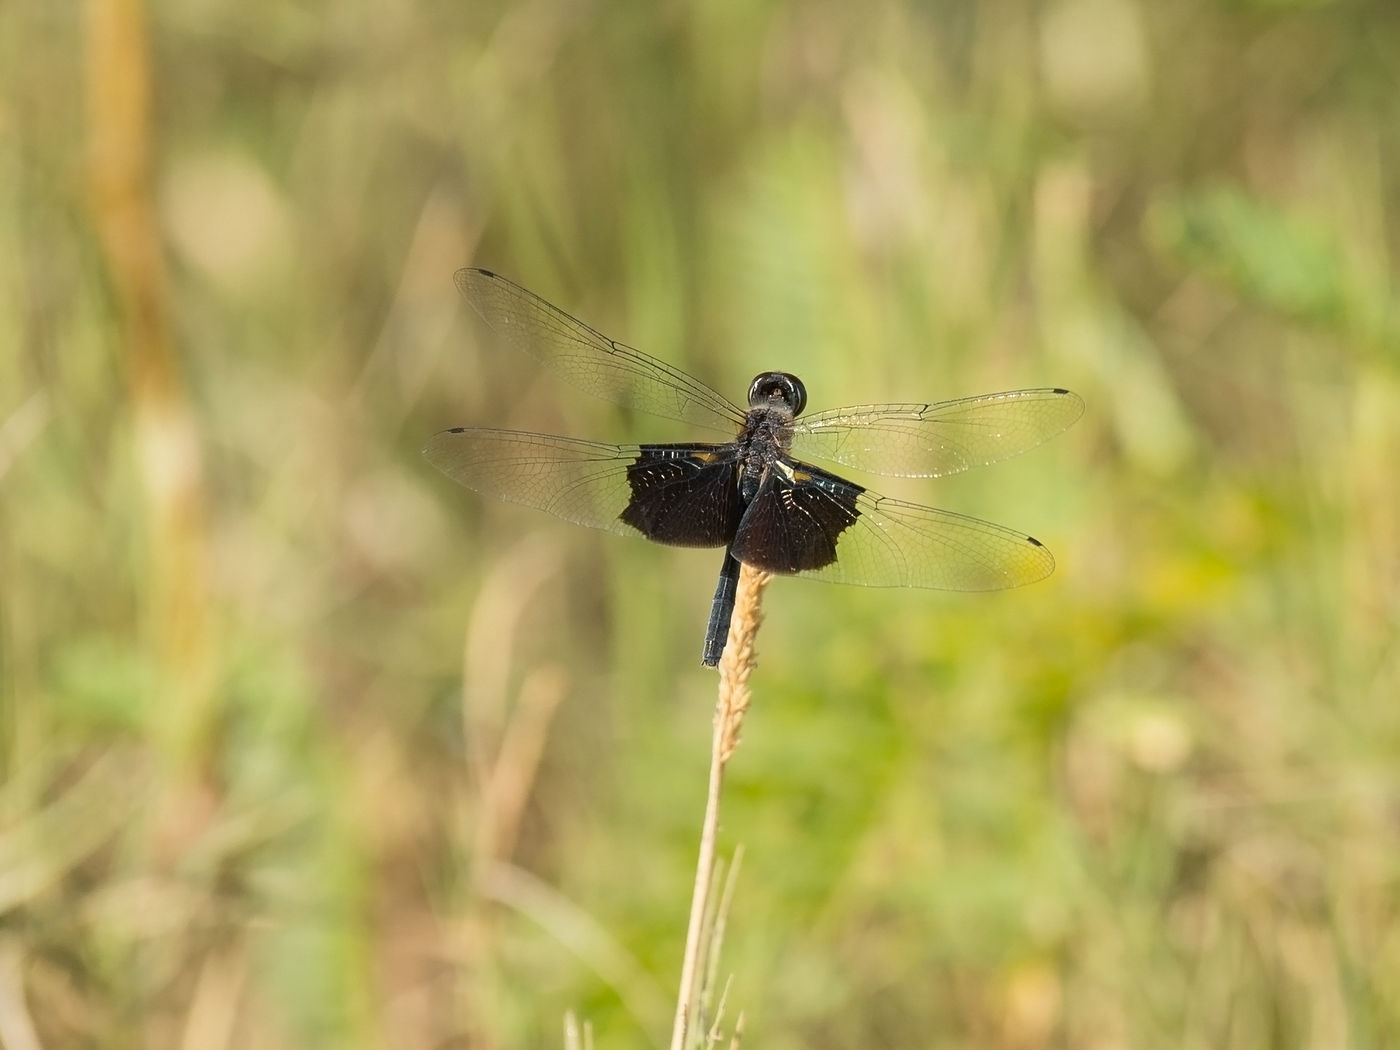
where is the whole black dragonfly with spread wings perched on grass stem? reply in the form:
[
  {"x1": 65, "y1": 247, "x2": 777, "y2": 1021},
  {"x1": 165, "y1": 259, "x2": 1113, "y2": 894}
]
[{"x1": 423, "y1": 269, "x2": 1084, "y2": 668}]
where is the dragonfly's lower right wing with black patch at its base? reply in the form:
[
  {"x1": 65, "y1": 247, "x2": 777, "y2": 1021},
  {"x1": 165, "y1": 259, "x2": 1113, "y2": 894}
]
[{"x1": 734, "y1": 463, "x2": 1054, "y2": 591}]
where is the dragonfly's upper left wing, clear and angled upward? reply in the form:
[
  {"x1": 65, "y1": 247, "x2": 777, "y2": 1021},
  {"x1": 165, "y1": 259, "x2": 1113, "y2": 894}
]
[{"x1": 455, "y1": 269, "x2": 743, "y2": 438}]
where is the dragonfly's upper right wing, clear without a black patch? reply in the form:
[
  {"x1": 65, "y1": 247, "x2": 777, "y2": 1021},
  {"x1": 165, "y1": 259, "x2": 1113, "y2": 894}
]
[{"x1": 792, "y1": 388, "x2": 1084, "y2": 477}]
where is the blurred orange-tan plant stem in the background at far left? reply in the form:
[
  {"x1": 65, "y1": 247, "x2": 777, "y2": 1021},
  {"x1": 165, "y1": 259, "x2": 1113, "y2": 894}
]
[{"x1": 87, "y1": 0, "x2": 218, "y2": 778}]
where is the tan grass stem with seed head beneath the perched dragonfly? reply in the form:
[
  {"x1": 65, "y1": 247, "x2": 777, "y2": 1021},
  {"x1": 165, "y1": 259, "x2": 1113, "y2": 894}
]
[{"x1": 671, "y1": 566, "x2": 773, "y2": 1050}]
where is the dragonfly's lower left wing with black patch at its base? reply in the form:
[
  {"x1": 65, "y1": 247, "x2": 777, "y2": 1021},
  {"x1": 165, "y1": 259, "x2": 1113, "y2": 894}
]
[{"x1": 423, "y1": 427, "x2": 738, "y2": 547}]
